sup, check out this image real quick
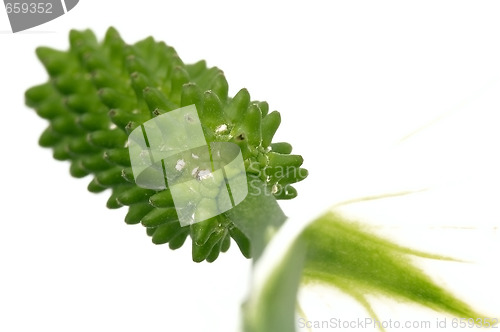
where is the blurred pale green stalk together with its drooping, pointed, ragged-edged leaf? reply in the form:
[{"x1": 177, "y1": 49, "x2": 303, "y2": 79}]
[{"x1": 243, "y1": 212, "x2": 484, "y2": 332}]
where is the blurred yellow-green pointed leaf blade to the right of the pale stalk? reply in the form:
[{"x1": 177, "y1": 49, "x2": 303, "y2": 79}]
[{"x1": 303, "y1": 213, "x2": 480, "y2": 317}]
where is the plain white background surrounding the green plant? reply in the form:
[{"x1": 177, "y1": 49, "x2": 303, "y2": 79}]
[{"x1": 0, "y1": 0, "x2": 500, "y2": 332}]
